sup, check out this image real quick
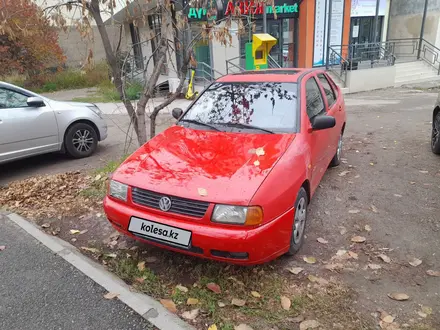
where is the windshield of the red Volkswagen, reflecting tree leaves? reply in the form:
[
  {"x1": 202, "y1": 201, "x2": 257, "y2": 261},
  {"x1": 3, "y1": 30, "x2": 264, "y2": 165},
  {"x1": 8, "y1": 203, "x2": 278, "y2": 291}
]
[{"x1": 180, "y1": 82, "x2": 297, "y2": 133}]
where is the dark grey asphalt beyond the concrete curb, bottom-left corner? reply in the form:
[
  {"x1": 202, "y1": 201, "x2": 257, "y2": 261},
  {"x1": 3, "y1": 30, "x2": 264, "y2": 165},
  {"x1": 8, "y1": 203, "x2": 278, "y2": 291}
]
[{"x1": 0, "y1": 215, "x2": 155, "y2": 330}]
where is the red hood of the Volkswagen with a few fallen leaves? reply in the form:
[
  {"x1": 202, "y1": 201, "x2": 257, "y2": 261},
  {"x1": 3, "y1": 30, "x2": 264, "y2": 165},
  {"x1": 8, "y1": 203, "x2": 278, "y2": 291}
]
[{"x1": 113, "y1": 126, "x2": 295, "y2": 205}]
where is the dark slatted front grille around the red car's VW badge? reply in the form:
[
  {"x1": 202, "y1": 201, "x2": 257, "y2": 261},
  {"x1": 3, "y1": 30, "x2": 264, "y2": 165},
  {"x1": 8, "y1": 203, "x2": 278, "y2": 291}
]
[{"x1": 131, "y1": 188, "x2": 209, "y2": 218}]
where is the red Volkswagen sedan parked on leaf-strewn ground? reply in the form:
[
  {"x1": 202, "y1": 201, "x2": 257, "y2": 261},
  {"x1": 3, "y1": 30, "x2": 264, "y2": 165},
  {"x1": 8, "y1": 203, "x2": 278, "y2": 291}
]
[{"x1": 104, "y1": 69, "x2": 346, "y2": 264}]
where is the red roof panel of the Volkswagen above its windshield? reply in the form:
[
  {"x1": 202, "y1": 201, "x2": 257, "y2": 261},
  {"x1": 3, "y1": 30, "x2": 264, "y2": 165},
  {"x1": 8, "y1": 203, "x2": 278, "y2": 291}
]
[{"x1": 217, "y1": 68, "x2": 314, "y2": 83}]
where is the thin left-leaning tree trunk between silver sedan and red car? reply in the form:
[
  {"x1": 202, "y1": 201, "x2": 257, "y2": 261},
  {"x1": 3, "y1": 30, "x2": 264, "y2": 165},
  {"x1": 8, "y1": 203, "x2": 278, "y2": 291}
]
[{"x1": 89, "y1": 0, "x2": 147, "y2": 145}]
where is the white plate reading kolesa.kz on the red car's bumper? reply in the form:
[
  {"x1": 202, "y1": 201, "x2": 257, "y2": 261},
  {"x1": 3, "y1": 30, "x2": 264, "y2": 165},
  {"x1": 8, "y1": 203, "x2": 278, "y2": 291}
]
[{"x1": 128, "y1": 217, "x2": 192, "y2": 248}]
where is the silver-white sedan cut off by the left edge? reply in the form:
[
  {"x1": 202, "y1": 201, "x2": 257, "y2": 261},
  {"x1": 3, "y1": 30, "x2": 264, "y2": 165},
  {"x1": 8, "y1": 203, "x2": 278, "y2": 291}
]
[{"x1": 0, "y1": 82, "x2": 107, "y2": 163}]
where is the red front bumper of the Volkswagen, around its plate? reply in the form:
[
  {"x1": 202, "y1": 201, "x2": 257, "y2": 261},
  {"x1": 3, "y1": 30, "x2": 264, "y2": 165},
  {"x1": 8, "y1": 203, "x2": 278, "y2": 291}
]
[{"x1": 104, "y1": 196, "x2": 294, "y2": 265}]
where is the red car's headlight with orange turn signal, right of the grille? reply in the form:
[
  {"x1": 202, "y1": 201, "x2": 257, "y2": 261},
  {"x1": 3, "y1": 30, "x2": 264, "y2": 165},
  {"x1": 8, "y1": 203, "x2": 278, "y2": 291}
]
[{"x1": 211, "y1": 205, "x2": 263, "y2": 226}]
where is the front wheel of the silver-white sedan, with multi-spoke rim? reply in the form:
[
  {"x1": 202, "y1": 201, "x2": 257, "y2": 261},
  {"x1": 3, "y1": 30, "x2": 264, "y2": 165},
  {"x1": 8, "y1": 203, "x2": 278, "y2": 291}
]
[{"x1": 64, "y1": 123, "x2": 98, "y2": 158}]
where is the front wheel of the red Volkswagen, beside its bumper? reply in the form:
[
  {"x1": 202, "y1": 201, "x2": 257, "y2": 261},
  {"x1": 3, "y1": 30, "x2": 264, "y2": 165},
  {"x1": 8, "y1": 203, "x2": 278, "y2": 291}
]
[{"x1": 286, "y1": 187, "x2": 309, "y2": 256}]
